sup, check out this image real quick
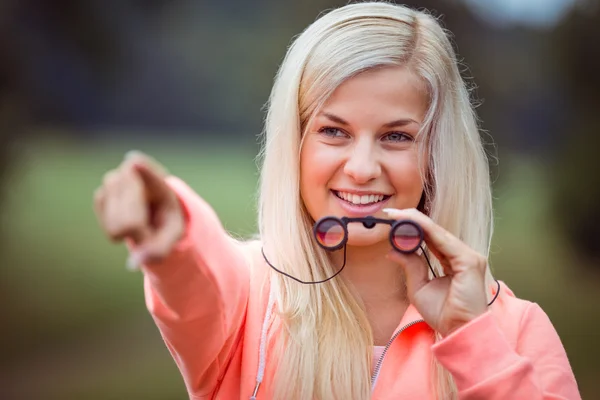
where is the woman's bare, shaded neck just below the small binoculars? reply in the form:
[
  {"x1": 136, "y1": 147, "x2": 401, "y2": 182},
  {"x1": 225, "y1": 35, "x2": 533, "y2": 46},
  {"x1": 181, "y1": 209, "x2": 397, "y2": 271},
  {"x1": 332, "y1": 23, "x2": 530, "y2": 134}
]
[{"x1": 333, "y1": 243, "x2": 408, "y2": 305}]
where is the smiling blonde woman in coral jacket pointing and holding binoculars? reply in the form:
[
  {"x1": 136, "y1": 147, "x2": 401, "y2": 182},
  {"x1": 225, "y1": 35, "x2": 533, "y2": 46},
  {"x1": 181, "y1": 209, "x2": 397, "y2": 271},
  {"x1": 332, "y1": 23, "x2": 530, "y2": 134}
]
[{"x1": 95, "y1": 3, "x2": 580, "y2": 400}]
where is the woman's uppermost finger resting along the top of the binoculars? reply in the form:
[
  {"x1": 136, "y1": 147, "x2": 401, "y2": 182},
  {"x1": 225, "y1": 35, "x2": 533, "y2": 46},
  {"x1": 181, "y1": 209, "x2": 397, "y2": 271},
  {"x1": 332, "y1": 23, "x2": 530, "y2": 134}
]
[{"x1": 384, "y1": 208, "x2": 471, "y2": 260}]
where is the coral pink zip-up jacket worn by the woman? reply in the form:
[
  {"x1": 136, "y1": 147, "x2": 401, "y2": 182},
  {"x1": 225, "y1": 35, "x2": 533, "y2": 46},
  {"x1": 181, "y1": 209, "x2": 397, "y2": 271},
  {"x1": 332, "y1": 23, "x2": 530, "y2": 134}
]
[{"x1": 137, "y1": 178, "x2": 580, "y2": 400}]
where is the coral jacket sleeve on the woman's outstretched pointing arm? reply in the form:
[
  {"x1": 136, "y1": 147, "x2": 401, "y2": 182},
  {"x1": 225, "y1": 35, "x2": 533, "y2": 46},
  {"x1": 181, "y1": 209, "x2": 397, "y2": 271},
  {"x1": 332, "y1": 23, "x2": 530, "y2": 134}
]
[{"x1": 135, "y1": 178, "x2": 250, "y2": 399}]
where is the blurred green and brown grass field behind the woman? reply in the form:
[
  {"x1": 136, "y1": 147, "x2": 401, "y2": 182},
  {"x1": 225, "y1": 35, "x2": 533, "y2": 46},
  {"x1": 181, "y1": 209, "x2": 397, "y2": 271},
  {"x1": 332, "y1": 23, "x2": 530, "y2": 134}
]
[{"x1": 0, "y1": 140, "x2": 600, "y2": 400}]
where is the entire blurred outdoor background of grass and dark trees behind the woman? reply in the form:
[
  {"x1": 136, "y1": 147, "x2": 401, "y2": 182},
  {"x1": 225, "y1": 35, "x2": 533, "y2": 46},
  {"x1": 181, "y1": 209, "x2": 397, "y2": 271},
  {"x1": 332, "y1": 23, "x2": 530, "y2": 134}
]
[{"x1": 0, "y1": 0, "x2": 600, "y2": 400}]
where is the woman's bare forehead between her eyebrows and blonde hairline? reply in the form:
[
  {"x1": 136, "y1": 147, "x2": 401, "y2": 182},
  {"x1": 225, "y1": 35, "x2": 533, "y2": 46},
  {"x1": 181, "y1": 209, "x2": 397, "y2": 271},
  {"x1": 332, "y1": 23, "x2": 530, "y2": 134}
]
[{"x1": 323, "y1": 67, "x2": 429, "y2": 122}]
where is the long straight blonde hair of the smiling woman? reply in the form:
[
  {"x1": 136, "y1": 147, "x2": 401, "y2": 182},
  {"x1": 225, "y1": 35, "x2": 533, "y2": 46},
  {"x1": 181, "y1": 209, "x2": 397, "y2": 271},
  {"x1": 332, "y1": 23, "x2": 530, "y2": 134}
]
[{"x1": 259, "y1": 2, "x2": 492, "y2": 400}]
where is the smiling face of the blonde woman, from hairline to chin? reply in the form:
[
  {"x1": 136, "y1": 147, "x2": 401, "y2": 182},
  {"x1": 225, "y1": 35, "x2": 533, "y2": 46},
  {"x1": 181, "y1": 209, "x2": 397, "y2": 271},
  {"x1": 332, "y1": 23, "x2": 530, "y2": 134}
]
[{"x1": 300, "y1": 67, "x2": 427, "y2": 246}]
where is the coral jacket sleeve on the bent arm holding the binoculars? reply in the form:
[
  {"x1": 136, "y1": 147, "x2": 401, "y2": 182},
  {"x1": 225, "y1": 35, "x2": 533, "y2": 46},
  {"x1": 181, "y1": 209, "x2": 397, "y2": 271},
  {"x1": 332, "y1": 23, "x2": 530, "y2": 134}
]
[{"x1": 433, "y1": 303, "x2": 581, "y2": 400}]
